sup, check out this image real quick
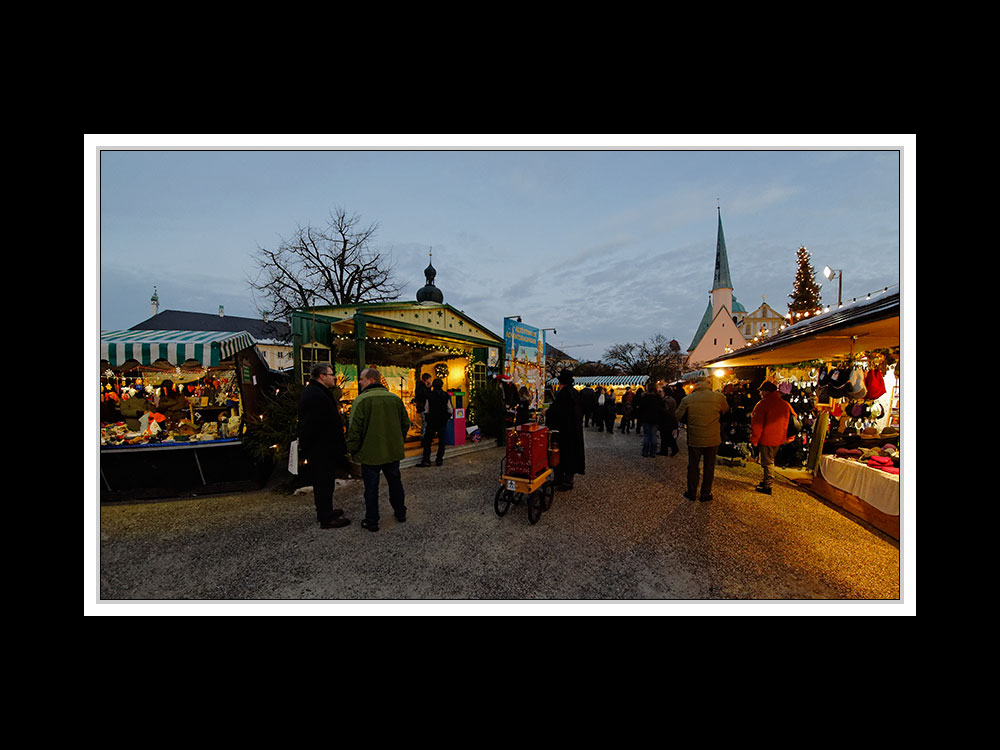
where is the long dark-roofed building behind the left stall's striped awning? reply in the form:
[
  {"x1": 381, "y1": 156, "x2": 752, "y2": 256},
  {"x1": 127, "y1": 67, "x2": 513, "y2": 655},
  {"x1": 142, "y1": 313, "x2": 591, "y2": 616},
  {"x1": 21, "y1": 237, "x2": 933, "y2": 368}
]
[{"x1": 132, "y1": 308, "x2": 295, "y2": 370}]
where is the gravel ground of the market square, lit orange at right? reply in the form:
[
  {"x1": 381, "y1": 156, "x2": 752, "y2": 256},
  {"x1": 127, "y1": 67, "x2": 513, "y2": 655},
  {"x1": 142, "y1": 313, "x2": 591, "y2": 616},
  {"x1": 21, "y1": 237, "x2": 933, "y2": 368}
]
[{"x1": 95, "y1": 429, "x2": 903, "y2": 614}]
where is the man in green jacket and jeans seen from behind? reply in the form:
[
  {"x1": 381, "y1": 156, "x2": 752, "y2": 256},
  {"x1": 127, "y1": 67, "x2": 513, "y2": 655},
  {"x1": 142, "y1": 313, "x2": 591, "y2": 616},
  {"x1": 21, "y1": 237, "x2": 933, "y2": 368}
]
[{"x1": 347, "y1": 367, "x2": 410, "y2": 531}]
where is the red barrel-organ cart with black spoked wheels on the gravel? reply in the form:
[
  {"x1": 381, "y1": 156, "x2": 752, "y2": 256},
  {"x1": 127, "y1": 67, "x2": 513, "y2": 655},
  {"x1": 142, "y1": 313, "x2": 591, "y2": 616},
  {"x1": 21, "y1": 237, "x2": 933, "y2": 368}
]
[{"x1": 493, "y1": 424, "x2": 559, "y2": 524}]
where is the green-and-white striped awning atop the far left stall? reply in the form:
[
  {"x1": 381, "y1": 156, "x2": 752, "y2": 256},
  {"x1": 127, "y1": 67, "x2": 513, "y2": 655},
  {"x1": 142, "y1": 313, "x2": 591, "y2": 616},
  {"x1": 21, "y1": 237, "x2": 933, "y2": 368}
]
[{"x1": 101, "y1": 330, "x2": 255, "y2": 367}]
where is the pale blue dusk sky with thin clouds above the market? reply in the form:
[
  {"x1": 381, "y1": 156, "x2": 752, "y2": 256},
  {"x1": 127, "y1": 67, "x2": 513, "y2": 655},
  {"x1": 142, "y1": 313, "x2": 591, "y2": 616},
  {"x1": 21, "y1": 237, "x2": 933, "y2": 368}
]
[{"x1": 84, "y1": 135, "x2": 916, "y2": 360}]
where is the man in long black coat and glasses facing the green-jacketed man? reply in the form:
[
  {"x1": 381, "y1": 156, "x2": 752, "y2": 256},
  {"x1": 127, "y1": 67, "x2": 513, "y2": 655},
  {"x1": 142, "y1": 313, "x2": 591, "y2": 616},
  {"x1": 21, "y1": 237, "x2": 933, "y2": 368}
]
[{"x1": 299, "y1": 362, "x2": 351, "y2": 529}]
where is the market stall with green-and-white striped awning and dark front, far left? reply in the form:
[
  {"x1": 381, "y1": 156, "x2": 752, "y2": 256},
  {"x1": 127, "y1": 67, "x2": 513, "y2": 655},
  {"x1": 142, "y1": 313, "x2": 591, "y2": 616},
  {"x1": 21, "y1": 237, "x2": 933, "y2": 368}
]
[{"x1": 100, "y1": 330, "x2": 267, "y2": 498}]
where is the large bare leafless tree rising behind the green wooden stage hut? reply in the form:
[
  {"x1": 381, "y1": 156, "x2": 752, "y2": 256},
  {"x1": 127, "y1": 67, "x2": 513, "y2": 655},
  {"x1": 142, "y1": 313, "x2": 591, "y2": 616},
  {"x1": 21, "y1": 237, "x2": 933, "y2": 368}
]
[{"x1": 248, "y1": 208, "x2": 402, "y2": 320}]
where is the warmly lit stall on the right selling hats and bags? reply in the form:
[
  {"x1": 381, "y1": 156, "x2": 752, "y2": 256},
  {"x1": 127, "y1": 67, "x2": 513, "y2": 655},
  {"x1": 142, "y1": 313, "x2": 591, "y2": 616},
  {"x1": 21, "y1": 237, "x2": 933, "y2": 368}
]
[{"x1": 706, "y1": 289, "x2": 901, "y2": 539}]
